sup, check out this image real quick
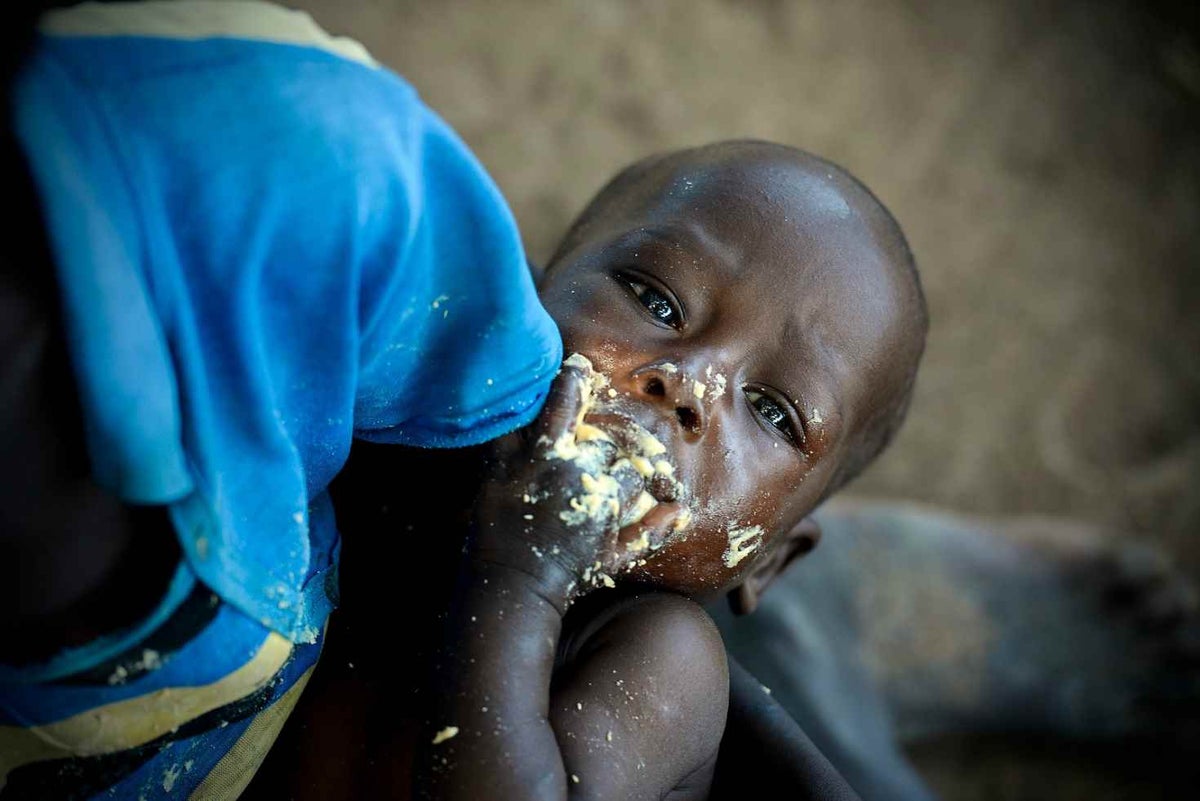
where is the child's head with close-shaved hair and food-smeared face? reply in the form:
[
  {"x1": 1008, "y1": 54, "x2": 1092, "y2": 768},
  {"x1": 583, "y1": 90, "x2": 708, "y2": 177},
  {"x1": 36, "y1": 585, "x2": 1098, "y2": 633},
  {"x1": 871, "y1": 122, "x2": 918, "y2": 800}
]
[{"x1": 540, "y1": 141, "x2": 928, "y2": 607}]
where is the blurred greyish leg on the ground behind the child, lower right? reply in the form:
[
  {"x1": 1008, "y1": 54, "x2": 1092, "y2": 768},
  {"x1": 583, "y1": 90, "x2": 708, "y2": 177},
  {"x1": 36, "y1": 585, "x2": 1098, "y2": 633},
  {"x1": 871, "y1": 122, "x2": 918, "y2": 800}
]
[{"x1": 716, "y1": 501, "x2": 1200, "y2": 799}]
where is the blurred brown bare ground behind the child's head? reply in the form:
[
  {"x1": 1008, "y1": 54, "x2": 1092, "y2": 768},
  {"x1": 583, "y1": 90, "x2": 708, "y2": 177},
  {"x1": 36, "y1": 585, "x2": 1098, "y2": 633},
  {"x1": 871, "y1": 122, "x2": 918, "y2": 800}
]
[{"x1": 292, "y1": 0, "x2": 1200, "y2": 801}]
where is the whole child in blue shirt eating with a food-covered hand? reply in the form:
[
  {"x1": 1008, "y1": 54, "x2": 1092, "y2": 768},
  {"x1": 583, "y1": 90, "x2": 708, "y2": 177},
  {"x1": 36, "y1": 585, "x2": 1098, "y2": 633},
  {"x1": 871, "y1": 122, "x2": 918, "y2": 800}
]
[{"x1": 0, "y1": 4, "x2": 923, "y2": 797}]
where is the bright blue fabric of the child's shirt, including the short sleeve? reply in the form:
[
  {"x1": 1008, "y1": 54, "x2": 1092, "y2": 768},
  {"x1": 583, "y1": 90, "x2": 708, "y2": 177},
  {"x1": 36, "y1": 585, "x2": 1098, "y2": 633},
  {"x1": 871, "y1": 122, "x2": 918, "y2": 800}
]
[{"x1": 14, "y1": 4, "x2": 562, "y2": 642}]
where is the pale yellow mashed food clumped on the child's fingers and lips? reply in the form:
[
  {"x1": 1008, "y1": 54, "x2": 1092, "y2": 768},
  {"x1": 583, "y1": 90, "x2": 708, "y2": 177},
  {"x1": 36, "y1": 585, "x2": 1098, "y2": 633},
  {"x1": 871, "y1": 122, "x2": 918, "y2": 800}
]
[{"x1": 541, "y1": 354, "x2": 691, "y2": 575}]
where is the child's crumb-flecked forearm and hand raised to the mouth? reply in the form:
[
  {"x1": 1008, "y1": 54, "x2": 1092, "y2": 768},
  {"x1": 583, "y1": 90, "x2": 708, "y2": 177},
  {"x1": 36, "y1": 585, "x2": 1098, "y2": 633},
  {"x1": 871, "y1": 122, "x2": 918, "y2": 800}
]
[{"x1": 416, "y1": 367, "x2": 700, "y2": 801}]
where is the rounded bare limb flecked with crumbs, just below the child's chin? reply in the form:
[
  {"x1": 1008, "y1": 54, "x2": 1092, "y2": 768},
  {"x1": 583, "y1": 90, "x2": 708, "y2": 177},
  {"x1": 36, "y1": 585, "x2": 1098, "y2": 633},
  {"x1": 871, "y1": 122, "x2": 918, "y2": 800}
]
[{"x1": 551, "y1": 592, "x2": 730, "y2": 799}]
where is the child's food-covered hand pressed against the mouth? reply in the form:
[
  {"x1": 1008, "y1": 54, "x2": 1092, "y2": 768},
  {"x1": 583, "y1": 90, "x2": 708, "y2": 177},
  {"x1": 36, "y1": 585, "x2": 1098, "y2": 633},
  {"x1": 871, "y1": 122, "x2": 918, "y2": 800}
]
[{"x1": 472, "y1": 361, "x2": 679, "y2": 603}]
